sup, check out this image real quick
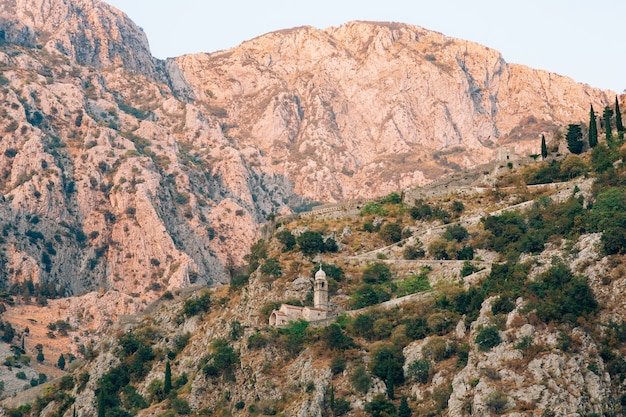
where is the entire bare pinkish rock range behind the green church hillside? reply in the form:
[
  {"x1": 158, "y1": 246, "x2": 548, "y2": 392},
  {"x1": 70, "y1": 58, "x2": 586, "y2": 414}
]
[{"x1": 0, "y1": 0, "x2": 612, "y2": 306}]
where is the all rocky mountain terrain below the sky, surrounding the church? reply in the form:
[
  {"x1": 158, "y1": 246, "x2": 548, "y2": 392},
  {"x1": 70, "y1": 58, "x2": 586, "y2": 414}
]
[{"x1": 0, "y1": 0, "x2": 626, "y2": 416}]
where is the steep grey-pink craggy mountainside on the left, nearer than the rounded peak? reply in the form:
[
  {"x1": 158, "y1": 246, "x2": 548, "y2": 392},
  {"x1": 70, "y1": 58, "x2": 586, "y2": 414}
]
[{"x1": 0, "y1": 1, "x2": 312, "y2": 304}]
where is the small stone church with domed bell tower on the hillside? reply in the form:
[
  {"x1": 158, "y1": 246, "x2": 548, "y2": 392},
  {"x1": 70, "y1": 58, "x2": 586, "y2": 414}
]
[{"x1": 269, "y1": 265, "x2": 329, "y2": 327}]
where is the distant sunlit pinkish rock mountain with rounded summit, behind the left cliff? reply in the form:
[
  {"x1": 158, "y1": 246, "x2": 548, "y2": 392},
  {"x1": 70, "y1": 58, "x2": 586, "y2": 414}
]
[{"x1": 176, "y1": 22, "x2": 613, "y2": 201}]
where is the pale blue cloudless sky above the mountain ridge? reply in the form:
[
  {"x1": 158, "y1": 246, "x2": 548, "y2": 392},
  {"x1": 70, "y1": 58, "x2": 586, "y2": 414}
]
[{"x1": 106, "y1": 0, "x2": 626, "y2": 93}]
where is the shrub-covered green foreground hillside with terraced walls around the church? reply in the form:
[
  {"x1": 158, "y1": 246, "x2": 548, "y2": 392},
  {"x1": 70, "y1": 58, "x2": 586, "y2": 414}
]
[{"x1": 14, "y1": 143, "x2": 626, "y2": 417}]
